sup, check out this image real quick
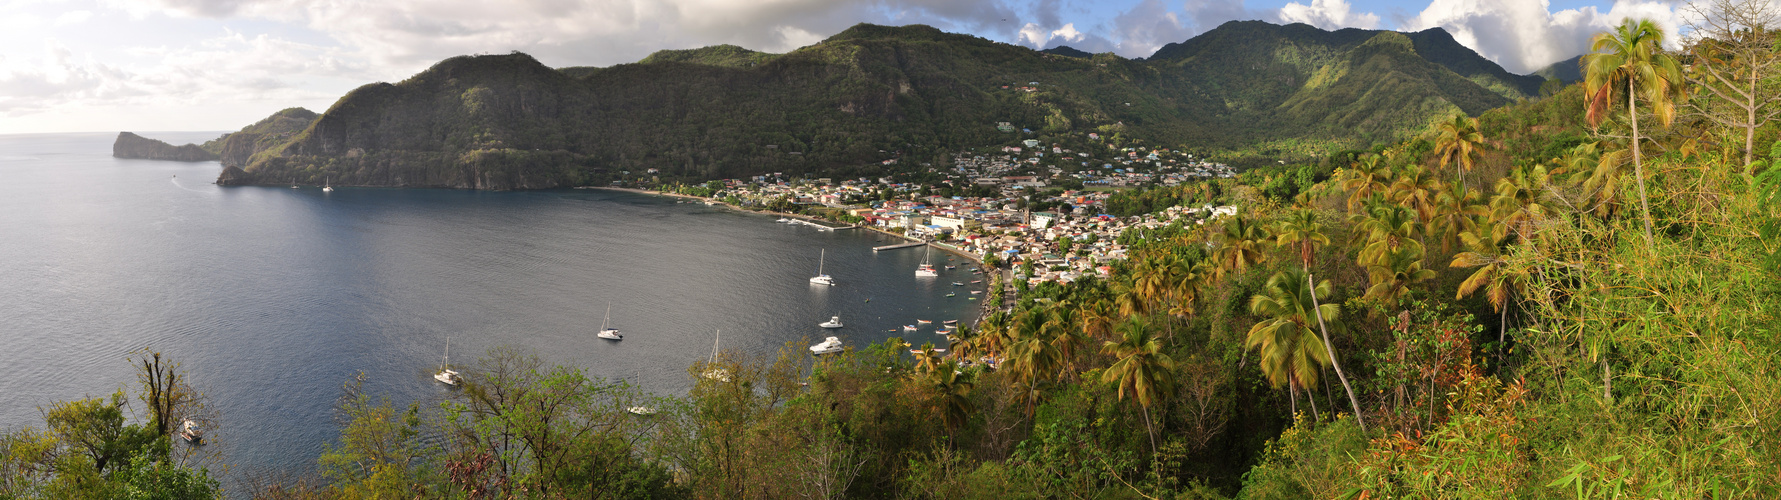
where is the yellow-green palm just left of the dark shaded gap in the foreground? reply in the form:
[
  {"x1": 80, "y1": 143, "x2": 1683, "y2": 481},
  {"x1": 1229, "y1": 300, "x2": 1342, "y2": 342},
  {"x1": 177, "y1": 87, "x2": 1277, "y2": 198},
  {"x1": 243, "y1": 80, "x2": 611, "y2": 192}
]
[{"x1": 1101, "y1": 317, "x2": 1175, "y2": 454}]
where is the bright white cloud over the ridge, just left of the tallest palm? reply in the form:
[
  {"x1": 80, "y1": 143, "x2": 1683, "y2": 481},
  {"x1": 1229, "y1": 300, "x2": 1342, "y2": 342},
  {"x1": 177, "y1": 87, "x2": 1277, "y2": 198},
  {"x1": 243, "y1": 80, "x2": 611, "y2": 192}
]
[{"x1": 1400, "y1": 0, "x2": 1683, "y2": 73}]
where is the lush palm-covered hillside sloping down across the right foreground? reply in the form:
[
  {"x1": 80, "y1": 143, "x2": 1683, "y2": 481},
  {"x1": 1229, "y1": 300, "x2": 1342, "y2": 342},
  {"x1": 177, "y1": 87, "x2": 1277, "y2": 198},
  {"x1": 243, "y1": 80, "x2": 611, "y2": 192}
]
[{"x1": 24, "y1": 0, "x2": 1781, "y2": 498}]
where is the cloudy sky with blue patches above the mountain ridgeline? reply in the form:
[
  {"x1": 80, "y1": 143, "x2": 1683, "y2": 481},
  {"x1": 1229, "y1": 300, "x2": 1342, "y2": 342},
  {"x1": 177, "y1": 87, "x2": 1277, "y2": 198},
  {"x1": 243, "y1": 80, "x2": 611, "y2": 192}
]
[{"x1": 0, "y1": 0, "x2": 1687, "y2": 133}]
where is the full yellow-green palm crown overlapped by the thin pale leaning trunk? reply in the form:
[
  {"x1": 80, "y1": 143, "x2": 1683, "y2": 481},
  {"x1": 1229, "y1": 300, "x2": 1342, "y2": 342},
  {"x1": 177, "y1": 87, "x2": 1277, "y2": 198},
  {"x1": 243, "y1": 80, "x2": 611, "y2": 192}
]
[{"x1": 1243, "y1": 270, "x2": 1341, "y2": 413}]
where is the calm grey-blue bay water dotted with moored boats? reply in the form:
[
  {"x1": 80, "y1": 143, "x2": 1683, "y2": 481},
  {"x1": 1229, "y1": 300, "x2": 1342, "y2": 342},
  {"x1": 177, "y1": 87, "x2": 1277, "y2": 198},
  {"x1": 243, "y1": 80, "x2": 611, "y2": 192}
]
[{"x1": 0, "y1": 133, "x2": 983, "y2": 480}]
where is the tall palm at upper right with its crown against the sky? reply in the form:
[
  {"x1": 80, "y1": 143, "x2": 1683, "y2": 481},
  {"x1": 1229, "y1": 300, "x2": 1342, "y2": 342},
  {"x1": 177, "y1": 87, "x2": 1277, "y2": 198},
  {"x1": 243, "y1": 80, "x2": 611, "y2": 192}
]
[{"x1": 1583, "y1": 18, "x2": 1683, "y2": 247}]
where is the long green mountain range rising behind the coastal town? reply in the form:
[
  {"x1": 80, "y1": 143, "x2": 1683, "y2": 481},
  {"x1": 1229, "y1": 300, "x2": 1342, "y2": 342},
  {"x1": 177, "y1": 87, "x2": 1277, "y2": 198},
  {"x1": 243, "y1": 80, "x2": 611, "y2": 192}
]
[{"x1": 204, "y1": 21, "x2": 1537, "y2": 189}]
